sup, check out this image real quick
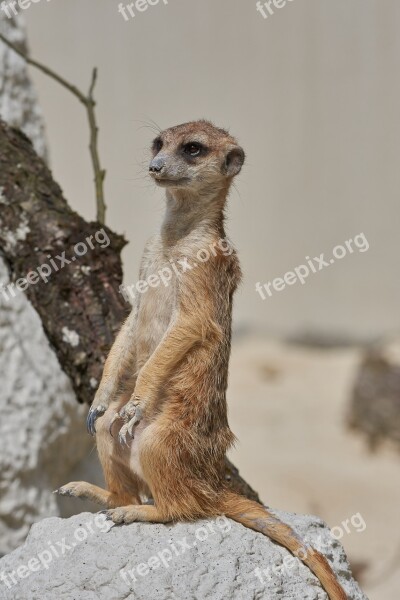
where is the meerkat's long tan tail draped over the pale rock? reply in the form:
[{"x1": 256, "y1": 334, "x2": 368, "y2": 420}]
[{"x1": 222, "y1": 492, "x2": 348, "y2": 600}]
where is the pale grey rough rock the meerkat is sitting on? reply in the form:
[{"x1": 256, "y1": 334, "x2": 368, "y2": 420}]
[{"x1": 0, "y1": 512, "x2": 367, "y2": 600}]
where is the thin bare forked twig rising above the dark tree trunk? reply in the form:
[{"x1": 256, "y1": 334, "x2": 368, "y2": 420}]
[{"x1": 0, "y1": 33, "x2": 106, "y2": 224}]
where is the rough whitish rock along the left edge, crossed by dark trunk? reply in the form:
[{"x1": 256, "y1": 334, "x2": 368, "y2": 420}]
[{"x1": 0, "y1": 12, "x2": 95, "y2": 555}]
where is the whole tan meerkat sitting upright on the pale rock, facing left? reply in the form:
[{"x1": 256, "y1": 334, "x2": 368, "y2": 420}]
[{"x1": 56, "y1": 121, "x2": 347, "y2": 600}]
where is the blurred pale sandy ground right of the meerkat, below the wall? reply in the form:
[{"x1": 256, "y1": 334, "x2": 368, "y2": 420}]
[{"x1": 228, "y1": 338, "x2": 400, "y2": 600}]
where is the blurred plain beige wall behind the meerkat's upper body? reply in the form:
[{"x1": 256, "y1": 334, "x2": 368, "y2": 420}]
[{"x1": 25, "y1": 0, "x2": 400, "y2": 338}]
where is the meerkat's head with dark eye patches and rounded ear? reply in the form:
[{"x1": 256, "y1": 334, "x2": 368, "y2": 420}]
[{"x1": 149, "y1": 121, "x2": 245, "y2": 193}]
